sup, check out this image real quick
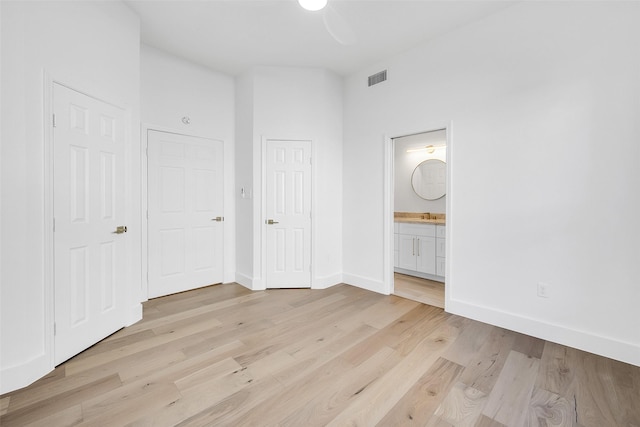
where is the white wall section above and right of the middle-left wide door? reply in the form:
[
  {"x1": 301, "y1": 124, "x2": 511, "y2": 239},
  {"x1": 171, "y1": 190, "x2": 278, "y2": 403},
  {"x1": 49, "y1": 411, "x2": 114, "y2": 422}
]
[{"x1": 140, "y1": 44, "x2": 236, "y2": 282}]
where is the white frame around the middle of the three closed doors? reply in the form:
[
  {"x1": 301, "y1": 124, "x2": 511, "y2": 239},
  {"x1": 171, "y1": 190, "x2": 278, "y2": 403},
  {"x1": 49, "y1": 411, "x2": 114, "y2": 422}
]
[{"x1": 140, "y1": 123, "x2": 228, "y2": 302}]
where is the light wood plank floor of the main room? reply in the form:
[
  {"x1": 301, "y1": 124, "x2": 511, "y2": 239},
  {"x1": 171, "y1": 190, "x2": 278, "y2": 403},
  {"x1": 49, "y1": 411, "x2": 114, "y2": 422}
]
[{"x1": 0, "y1": 284, "x2": 640, "y2": 427}]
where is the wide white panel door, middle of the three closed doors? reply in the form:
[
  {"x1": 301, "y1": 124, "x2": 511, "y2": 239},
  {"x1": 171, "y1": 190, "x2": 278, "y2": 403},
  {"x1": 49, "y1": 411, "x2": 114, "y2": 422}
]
[{"x1": 147, "y1": 130, "x2": 224, "y2": 298}]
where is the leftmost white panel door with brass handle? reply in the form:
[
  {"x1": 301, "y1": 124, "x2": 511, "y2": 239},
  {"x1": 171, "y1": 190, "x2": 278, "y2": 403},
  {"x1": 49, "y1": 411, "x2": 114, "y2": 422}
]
[{"x1": 53, "y1": 84, "x2": 128, "y2": 365}]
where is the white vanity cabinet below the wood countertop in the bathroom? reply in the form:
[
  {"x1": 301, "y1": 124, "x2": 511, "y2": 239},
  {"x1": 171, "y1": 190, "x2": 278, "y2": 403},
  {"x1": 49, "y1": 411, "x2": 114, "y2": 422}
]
[{"x1": 394, "y1": 222, "x2": 445, "y2": 281}]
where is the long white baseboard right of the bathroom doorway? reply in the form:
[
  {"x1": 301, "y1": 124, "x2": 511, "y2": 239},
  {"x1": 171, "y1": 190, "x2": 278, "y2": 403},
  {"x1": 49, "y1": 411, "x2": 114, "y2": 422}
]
[{"x1": 445, "y1": 299, "x2": 640, "y2": 366}]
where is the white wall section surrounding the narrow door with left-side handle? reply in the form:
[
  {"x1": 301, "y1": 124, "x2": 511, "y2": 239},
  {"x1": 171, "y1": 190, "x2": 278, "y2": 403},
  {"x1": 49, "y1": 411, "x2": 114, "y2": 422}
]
[{"x1": 236, "y1": 67, "x2": 342, "y2": 289}]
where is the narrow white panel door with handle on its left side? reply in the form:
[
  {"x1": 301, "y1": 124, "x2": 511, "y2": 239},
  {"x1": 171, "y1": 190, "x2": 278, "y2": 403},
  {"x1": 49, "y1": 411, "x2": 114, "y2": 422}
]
[{"x1": 264, "y1": 140, "x2": 311, "y2": 288}]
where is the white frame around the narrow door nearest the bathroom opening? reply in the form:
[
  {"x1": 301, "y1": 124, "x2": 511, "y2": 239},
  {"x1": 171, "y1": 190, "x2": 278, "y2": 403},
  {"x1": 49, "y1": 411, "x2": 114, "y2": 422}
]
[{"x1": 260, "y1": 135, "x2": 316, "y2": 290}]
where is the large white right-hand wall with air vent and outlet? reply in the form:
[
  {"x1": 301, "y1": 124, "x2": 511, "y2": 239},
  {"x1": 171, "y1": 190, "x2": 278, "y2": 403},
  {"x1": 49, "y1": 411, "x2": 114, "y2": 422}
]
[{"x1": 344, "y1": 2, "x2": 640, "y2": 365}]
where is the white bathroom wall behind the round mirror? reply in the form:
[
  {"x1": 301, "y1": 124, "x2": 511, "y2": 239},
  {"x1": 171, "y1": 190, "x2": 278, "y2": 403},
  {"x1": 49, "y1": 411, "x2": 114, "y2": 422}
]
[{"x1": 393, "y1": 130, "x2": 447, "y2": 213}]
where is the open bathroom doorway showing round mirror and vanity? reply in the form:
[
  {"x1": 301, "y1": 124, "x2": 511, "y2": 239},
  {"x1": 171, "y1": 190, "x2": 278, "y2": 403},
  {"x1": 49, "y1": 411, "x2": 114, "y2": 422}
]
[{"x1": 388, "y1": 127, "x2": 449, "y2": 308}]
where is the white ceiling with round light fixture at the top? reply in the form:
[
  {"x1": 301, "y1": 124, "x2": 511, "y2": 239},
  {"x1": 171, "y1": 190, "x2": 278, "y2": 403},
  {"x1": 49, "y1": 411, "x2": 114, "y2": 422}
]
[{"x1": 125, "y1": 0, "x2": 514, "y2": 75}]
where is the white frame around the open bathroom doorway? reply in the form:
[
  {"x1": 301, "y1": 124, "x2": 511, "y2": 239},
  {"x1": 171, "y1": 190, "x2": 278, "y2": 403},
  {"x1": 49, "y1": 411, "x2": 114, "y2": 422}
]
[{"x1": 382, "y1": 121, "x2": 453, "y2": 311}]
